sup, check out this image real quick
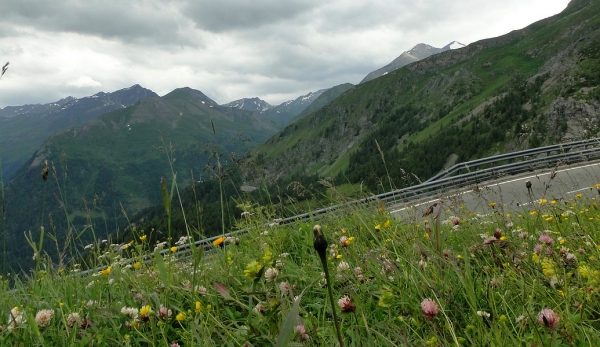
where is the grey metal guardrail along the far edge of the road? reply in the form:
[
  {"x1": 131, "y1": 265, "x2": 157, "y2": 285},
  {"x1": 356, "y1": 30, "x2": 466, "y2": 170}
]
[{"x1": 79, "y1": 138, "x2": 600, "y2": 275}]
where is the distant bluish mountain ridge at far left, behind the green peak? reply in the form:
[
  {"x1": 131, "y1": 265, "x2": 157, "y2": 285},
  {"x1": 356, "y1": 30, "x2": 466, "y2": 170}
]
[{"x1": 0, "y1": 84, "x2": 158, "y2": 182}]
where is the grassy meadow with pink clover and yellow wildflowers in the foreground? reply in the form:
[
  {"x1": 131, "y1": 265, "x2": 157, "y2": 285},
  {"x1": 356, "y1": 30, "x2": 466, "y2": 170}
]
[{"x1": 0, "y1": 178, "x2": 600, "y2": 346}]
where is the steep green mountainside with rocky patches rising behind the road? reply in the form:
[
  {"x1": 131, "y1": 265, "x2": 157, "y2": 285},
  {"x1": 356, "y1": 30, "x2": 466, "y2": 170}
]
[{"x1": 245, "y1": 0, "x2": 600, "y2": 192}]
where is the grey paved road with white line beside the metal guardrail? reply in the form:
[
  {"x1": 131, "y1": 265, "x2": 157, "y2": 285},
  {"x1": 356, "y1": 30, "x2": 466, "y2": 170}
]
[{"x1": 389, "y1": 162, "x2": 600, "y2": 223}]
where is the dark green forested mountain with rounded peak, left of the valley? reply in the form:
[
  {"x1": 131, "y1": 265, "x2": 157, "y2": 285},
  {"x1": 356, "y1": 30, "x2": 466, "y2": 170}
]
[{"x1": 6, "y1": 88, "x2": 276, "y2": 272}]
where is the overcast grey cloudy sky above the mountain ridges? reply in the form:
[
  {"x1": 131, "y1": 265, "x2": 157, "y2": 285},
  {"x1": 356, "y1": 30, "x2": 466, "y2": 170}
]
[{"x1": 0, "y1": 0, "x2": 569, "y2": 108}]
